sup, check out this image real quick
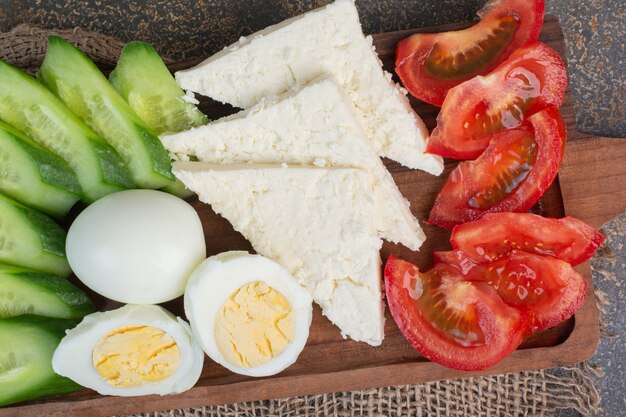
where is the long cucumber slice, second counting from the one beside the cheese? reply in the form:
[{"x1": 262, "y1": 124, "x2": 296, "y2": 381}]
[{"x1": 37, "y1": 36, "x2": 174, "y2": 188}]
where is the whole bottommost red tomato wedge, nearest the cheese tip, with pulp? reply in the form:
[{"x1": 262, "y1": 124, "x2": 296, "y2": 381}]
[{"x1": 385, "y1": 255, "x2": 527, "y2": 371}]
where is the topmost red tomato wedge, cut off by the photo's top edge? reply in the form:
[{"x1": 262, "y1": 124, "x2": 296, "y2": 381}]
[{"x1": 396, "y1": 0, "x2": 545, "y2": 106}]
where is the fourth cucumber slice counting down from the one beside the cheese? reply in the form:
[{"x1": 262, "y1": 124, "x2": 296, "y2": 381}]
[{"x1": 0, "y1": 122, "x2": 81, "y2": 217}]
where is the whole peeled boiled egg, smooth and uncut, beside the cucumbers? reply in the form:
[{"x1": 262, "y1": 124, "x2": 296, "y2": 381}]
[{"x1": 66, "y1": 190, "x2": 206, "y2": 304}]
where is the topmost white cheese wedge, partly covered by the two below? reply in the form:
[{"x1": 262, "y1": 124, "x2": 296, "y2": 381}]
[{"x1": 176, "y1": 0, "x2": 443, "y2": 175}]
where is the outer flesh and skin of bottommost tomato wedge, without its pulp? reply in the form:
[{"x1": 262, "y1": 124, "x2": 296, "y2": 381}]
[{"x1": 385, "y1": 255, "x2": 528, "y2": 371}]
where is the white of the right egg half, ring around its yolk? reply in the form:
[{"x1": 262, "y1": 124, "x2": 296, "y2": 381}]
[{"x1": 185, "y1": 251, "x2": 313, "y2": 377}]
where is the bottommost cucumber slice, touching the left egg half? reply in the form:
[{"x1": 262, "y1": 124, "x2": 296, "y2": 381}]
[{"x1": 0, "y1": 315, "x2": 81, "y2": 406}]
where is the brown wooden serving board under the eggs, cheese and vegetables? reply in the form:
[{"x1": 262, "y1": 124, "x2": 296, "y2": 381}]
[{"x1": 0, "y1": 16, "x2": 626, "y2": 417}]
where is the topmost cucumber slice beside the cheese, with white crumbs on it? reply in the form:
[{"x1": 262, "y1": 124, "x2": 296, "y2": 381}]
[{"x1": 109, "y1": 41, "x2": 209, "y2": 135}]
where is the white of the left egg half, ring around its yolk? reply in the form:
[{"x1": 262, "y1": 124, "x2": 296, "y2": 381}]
[{"x1": 52, "y1": 304, "x2": 204, "y2": 397}]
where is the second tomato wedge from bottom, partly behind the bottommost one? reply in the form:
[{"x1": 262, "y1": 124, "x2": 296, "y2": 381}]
[{"x1": 435, "y1": 250, "x2": 587, "y2": 330}]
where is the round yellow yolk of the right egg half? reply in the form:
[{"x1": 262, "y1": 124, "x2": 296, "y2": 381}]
[{"x1": 215, "y1": 281, "x2": 295, "y2": 368}]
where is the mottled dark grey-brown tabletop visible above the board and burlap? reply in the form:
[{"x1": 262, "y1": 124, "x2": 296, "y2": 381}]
[{"x1": 0, "y1": 0, "x2": 626, "y2": 137}]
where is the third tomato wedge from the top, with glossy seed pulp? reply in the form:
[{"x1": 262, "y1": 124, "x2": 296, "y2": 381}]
[{"x1": 428, "y1": 107, "x2": 567, "y2": 228}]
